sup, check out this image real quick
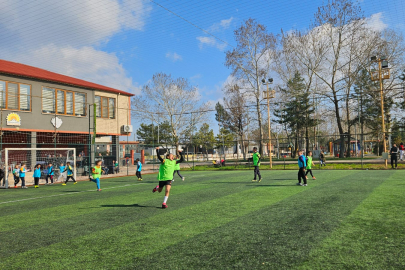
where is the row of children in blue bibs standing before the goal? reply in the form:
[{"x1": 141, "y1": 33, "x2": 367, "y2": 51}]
[{"x1": 12, "y1": 162, "x2": 77, "y2": 188}]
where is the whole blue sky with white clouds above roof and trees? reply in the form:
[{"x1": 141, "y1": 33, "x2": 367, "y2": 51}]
[{"x1": 0, "y1": 0, "x2": 405, "y2": 135}]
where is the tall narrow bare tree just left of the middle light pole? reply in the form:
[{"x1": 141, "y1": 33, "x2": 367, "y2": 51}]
[{"x1": 225, "y1": 18, "x2": 276, "y2": 154}]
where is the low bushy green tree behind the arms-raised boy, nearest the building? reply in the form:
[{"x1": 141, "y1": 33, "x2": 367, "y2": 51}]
[{"x1": 136, "y1": 121, "x2": 174, "y2": 148}]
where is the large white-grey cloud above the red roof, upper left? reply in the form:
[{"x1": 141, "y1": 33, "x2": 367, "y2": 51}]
[{"x1": 0, "y1": 0, "x2": 151, "y2": 93}]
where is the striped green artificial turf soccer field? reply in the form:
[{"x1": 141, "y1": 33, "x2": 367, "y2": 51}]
[{"x1": 0, "y1": 170, "x2": 405, "y2": 269}]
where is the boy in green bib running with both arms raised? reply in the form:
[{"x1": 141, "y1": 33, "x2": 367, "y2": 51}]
[{"x1": 152, "y1": 147, "x2": 183, "y2": 208}]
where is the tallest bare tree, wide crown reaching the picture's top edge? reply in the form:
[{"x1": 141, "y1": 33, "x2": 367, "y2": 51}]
[{"x1": 288, "y1": 0, "x2": 384, "y2": 157}]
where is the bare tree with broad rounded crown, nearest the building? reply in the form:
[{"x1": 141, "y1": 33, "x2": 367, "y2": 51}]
[{"x1": 132, "y1": 73, "x2": 207, "y2": 152}]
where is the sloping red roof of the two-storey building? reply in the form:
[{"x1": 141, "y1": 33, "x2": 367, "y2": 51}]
[{"x1": 0, "y1": 59, "x2": 133, "y2": 96}]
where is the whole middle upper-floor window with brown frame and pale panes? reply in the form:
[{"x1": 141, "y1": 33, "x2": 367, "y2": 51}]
[{"x1": 42, "y1": 87, "x2": 86, "y2": 116}]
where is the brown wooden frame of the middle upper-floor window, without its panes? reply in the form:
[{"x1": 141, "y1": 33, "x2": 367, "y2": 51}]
[{"x1": 41, "y1": 85, "x2": 87, "y2": 117}]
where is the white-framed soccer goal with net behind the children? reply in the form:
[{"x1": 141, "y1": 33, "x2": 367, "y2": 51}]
[{"x1": 0, "y1": 148, "x2": 77, "y2": 188}]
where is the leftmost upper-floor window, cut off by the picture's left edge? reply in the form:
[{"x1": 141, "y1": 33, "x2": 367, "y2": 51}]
[{"x1": 0, "y1": 81, "x2": 31, "y2": 111}]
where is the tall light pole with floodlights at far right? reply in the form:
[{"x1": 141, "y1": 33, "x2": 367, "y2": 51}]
[{"x1": 370, "y1": 56, "x2": 390, "y2": 168}]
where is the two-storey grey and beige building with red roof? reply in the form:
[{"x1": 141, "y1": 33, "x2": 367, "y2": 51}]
[{"x1": 0, "y1": 60, "x2": 133, "y2": 160}]
